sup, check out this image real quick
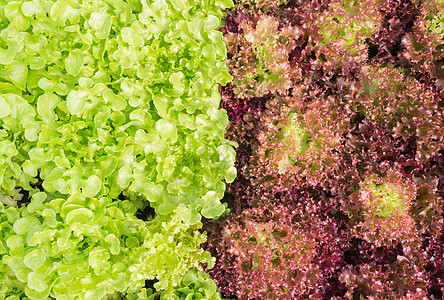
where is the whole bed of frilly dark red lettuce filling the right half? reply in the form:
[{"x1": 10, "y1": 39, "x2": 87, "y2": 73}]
[{"x1": 206, "y1": 0, "x2": 444, "y2": 299}]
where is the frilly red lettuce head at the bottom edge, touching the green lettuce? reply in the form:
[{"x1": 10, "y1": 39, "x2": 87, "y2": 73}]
[{"x1": 203, "y1": 191, "x2": 346, "y2": 299}]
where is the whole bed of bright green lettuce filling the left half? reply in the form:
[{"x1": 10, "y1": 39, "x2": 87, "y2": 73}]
[{"x1": 0, "y1": 0, "x2": 236, "y2": 300}]
